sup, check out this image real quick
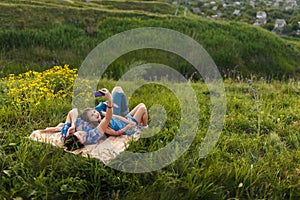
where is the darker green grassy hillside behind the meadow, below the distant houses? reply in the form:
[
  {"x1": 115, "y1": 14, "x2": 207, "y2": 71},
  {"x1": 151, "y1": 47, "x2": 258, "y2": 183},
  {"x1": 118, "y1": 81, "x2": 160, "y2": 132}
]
[{"x1": 0, "y1": 0, "x2": 300, "y2": 78}]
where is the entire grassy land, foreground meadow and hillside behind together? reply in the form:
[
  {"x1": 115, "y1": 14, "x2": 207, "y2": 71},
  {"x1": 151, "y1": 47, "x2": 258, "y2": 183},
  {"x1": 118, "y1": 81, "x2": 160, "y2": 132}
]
[{"x1": 0, "y1": 0, "x2": 300, "y2": 200}]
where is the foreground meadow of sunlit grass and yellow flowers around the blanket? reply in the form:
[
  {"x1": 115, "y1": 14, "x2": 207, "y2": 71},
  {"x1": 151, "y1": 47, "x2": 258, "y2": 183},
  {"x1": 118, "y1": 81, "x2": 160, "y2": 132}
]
[{"x1": 0, "y1": 65, "x2": 300, "y2": 199}]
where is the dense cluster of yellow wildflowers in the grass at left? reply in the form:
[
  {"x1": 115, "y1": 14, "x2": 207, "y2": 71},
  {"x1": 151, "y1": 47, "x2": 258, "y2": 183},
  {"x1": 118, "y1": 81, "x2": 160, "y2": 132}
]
[{"x1": 1, "y1": 65, "x2": 77, "y2": 108}]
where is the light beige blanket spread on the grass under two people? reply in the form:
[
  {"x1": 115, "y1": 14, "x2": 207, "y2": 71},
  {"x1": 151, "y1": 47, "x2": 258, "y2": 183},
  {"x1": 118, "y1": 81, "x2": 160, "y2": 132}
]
[{"x1": 29, "y1": 130, "x2": 140, "y2": 164}]
